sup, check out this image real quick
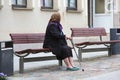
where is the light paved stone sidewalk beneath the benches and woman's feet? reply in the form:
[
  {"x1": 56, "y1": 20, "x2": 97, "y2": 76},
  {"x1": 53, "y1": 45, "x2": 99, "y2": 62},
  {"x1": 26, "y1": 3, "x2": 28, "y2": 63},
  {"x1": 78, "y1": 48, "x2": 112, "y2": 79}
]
[{"x1": 8, "y1": 53, "x2": 120, "y2": 80}]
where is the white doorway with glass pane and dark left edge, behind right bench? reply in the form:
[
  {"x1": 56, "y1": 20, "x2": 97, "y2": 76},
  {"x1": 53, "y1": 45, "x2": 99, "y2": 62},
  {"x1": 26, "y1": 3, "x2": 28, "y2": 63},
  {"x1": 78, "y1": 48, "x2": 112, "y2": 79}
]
[{"x1": 88, "y1": 0, "x2": 113, "y2": 32}]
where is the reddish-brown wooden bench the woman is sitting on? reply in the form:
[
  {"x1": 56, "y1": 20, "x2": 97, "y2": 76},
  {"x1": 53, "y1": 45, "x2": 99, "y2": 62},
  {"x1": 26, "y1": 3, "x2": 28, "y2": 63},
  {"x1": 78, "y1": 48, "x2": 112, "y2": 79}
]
[{"x1": 10, "y1": 33, "x2": 62, "y2": 73}]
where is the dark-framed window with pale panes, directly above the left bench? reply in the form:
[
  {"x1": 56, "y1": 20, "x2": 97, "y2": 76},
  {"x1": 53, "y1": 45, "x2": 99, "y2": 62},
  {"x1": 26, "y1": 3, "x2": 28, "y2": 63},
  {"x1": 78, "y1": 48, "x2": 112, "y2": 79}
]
[{"x1": 12, "y1": 0, "x2": 27, "y2": 8}]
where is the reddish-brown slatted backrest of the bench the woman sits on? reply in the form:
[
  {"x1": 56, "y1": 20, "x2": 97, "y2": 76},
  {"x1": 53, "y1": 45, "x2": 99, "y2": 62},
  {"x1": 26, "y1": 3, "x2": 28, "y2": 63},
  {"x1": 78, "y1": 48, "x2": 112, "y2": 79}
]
[{"x1": 10, "y1": 33, "x2": 45, "y2": 44}]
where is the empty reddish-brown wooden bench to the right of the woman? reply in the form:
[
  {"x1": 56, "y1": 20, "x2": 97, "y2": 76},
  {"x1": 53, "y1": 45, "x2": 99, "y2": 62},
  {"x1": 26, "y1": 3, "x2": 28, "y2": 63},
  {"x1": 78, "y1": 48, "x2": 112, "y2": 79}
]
[{"x1": 71, "y1": 28, "x2": 120, "y2": 61}]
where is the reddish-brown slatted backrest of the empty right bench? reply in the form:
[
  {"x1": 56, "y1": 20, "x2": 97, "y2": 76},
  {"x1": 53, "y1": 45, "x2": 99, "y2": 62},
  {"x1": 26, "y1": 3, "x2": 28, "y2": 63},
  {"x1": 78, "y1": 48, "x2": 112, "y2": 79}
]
[{"x1": 71, "y1": 28, "x2": 107, "y2": 40}]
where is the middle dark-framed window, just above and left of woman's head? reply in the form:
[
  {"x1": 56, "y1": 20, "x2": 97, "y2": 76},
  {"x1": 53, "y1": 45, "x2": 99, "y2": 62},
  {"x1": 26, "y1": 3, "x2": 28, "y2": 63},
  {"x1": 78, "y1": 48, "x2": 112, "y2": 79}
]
[{"x1": 41, "y1": 0, "x2": 53, "y2": 9}]
